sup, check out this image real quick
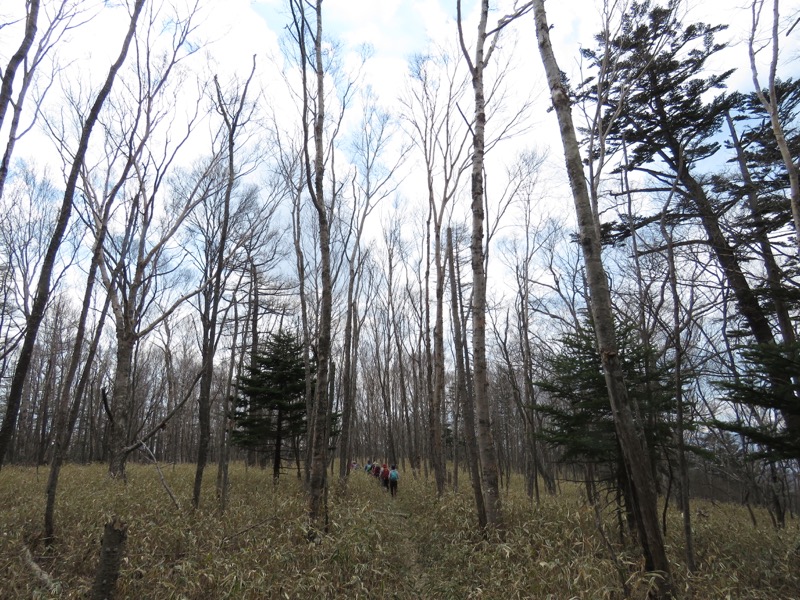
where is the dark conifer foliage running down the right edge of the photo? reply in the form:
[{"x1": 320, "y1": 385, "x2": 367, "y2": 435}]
[{"x1": 716, "y1": 79, "x2": 800, "y2": 460}]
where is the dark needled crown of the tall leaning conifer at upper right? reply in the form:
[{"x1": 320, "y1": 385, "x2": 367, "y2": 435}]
[{"x1": 578, "y1": 0, "x2": 733, "y2": 173}]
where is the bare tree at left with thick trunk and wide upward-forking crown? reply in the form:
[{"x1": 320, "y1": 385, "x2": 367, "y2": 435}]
[{"x1": 86, "y1": 5, "x2": 212, "y2": 477}]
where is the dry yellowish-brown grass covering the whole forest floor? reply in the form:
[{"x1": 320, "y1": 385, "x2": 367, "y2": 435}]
[{"x1": 0, "y1": 465, "x2": 800, "y2": 600}]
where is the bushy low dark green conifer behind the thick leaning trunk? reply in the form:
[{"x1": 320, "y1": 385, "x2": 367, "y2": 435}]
[{"x1": 536, "y1": 317, "x2": 675, "y2": 503}]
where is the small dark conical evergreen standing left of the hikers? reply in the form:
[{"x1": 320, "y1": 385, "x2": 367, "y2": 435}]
[{"x1": 231, "y1": 330, "x2": 306, "y2": 479}]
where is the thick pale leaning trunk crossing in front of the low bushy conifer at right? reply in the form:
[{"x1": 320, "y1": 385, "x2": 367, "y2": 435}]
[{"x1": 533, "y1": 0, "x2": 672, "y2": 597}]
